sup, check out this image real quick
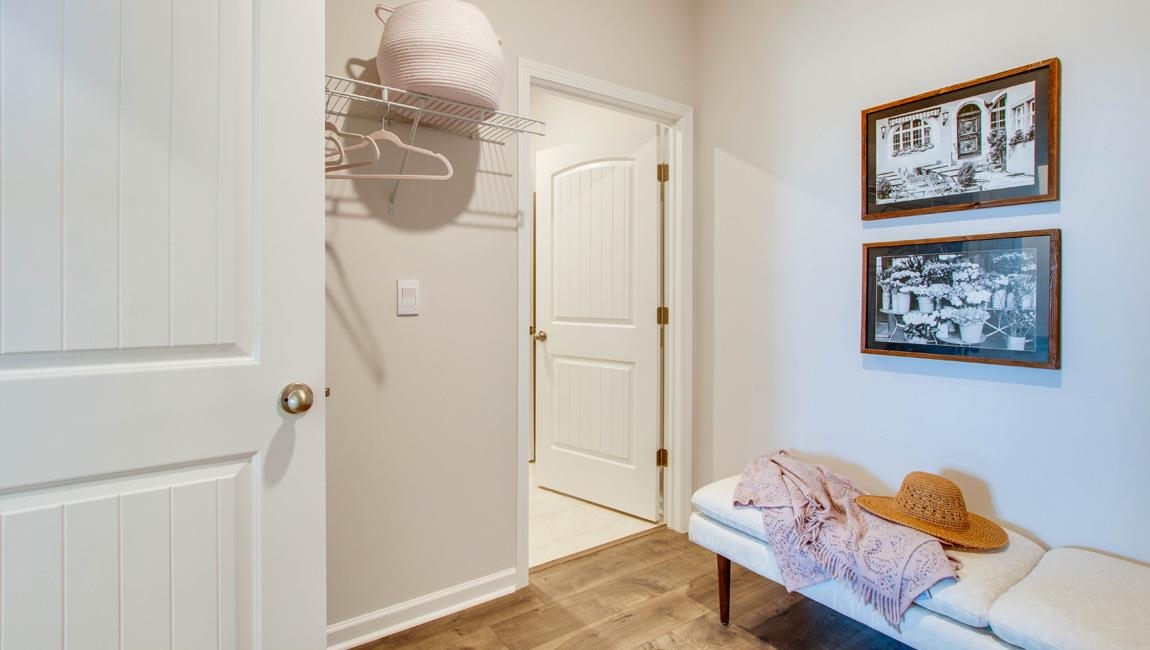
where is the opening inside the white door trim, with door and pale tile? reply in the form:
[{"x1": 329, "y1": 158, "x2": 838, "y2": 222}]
[{"x1": 528, "y1": 86, "x2": 666, "y2": 567}]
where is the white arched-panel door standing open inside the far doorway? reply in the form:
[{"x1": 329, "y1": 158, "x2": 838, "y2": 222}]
[{"x1": 535, "y1": 132, "x2": 659, "y2": 521}]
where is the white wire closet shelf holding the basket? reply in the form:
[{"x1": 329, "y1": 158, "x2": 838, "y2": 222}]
[{"x1": 324, "y1": 75, "x2": 545, "y2": 145}]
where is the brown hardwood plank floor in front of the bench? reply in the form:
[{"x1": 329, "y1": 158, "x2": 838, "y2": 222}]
[{"x1": 357, "y1": 529, "x2": 906, "y2": 650}]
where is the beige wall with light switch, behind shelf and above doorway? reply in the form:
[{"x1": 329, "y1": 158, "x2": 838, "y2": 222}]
[{"x1": 327, "y1": 0, "x2": 696, "y2": 622}]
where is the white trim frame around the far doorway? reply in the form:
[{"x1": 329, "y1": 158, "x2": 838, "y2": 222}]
[{"x1": 515, "y1": 59, "x2": 693, "y2": 587}]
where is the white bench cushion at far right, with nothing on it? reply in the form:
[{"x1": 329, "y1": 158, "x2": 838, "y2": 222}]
[{"x1": 990, "y1": 549, "x2": 1150, "y2": 650}]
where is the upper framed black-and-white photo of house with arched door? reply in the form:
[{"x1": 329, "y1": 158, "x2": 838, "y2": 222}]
[{"x1": 863, "y1": 59, "x2": 1059, "y2": 220}]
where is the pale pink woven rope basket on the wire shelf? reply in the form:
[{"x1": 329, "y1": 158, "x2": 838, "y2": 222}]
[{"x1": 375, "y1": 0, "x2": 504, "y2": 109}]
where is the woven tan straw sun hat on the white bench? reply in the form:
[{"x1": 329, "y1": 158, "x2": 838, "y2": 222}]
[{"x1": 856, "y1": 472, "x2": 1006, "y2": 551}]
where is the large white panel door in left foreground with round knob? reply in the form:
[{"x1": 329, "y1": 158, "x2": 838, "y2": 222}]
[{"x1": 0, "y1": 0, "x2": 324, "y2": 650}]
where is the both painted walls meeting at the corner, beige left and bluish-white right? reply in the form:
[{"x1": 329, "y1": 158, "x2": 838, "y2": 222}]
[{"x1": 327, "y1": 0, "x2": 1150, "y2": 635}]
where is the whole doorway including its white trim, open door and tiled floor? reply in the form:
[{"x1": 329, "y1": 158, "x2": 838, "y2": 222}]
[{"x1": 516, "y1": 61, "x2": 691, "y2": 577}]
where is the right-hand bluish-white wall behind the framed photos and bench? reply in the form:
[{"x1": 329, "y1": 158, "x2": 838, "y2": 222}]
[{"x1": 695, "y1": 0, "x2": 1150, "y2": 561}]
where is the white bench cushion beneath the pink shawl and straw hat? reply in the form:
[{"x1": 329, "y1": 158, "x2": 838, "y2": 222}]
[{"x1": 691, "y1": 475, "x2": 1042, "y2": 627}]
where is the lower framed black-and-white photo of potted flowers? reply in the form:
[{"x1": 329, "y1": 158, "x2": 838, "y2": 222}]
[{"x1": 863, "y1": 230, "x2": 1061, "y2": 368}]
